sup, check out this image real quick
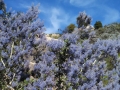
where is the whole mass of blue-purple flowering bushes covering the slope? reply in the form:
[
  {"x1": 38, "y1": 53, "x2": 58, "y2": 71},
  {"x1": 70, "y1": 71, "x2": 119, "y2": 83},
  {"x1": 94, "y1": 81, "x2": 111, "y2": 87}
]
[{"x1": 0, "y1": 0, "x2": 120, "y2": 90}]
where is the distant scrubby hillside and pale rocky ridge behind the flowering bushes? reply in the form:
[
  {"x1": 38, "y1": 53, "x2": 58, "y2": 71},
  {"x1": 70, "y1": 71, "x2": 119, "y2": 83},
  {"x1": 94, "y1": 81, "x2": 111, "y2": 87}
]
[{"x1": 46, "y1": 23, "x2": 120, "y2": 40}]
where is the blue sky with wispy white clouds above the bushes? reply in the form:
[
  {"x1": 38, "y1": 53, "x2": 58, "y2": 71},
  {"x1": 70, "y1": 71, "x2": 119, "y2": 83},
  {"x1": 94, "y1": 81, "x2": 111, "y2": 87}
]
[{"x1": 4, "y1": 0, "x2": 120, "y2": 33}]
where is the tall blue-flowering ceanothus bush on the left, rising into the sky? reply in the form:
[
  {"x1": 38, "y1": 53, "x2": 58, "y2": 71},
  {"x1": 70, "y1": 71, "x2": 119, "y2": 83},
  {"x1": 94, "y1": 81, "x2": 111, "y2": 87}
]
[{"x1": 0, "y1": 1, "x2": 46, "y2": 88}]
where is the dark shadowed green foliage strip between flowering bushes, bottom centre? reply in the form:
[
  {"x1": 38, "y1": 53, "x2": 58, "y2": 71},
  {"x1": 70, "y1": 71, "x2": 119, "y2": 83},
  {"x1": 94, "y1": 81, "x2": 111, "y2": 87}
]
[{"x1": 50, "y1": 40, "x2": 70, "y2": 90}]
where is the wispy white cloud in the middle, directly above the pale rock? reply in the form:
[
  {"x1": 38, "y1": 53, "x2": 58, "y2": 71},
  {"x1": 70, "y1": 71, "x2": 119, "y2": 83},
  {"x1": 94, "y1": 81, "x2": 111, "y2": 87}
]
[{"x1": 46, "y1": 8, "x2": 69, "y2": 33}]
